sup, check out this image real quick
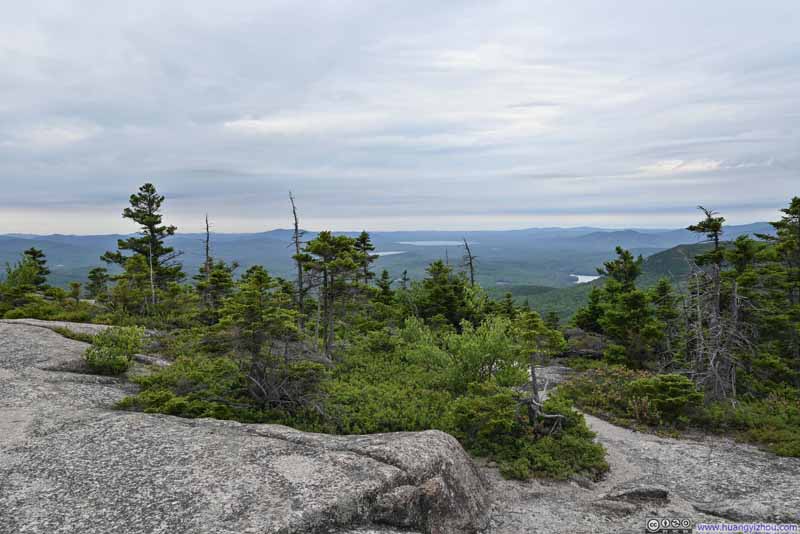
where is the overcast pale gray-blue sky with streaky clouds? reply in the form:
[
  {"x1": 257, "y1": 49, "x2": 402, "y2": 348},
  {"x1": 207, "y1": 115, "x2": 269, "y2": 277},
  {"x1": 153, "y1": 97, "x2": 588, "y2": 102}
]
[{"x1": 0, "y1": 0, "x2": 800, "y2": 233}]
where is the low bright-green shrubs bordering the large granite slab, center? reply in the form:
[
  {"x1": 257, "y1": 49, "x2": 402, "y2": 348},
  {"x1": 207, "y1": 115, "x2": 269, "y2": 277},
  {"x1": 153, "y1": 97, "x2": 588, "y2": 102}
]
[{"x1": 119, "y1": 320, "x2": 608, "y2": 479}]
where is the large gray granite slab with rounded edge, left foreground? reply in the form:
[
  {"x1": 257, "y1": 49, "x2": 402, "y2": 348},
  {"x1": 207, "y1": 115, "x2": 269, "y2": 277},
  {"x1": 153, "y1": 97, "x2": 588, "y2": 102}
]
[{"x1": 0, "y1": 322, "x2": 489, "y2": 534}]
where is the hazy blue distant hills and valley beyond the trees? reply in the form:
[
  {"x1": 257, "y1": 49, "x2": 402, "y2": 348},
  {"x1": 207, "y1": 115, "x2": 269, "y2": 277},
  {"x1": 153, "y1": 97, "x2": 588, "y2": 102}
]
[{"x1": 0, "y1": 222, "x2": 772, "y2": 287}]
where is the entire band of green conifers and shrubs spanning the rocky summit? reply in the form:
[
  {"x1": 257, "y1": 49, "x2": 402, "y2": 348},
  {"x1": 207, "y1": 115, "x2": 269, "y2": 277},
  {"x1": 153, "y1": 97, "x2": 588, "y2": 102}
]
[{"x1": 0, "y1": 184, "x2": 800, "y2": 479}]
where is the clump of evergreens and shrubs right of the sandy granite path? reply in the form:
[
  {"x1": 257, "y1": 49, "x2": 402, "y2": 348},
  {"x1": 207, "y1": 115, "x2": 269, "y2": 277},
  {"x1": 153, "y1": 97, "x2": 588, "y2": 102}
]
[{"x1": 561, "y1": 198, "x2": 800, "y2": 456}]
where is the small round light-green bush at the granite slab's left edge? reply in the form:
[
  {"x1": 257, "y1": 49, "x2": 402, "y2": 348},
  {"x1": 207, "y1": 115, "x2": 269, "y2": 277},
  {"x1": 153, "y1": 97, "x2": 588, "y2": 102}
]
[{"x1": 84, "y1": 327, "x2": 144, "y2": 375}]
